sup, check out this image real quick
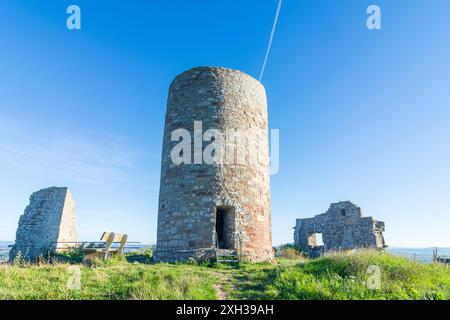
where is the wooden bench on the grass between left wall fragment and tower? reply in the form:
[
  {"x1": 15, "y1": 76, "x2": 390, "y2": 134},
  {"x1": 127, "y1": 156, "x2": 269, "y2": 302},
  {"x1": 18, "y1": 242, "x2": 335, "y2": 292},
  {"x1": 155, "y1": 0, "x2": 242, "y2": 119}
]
[{"x1": 82, "y1": 232, "x2": 128, "y2": 262}]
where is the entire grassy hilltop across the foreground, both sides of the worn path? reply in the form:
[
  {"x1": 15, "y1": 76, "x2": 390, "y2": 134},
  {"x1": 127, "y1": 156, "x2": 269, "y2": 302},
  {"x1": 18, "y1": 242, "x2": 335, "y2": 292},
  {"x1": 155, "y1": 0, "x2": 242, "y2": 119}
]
[{"x1": 0, "y1": 251, "x2": 450, "y2": 300}]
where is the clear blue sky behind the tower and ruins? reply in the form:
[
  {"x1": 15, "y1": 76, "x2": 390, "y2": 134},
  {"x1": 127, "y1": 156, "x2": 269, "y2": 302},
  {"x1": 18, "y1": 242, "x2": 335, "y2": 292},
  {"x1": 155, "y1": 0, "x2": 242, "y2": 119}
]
[{"x1": 0, "y1": 0, "x2": 450, "y2": 246}]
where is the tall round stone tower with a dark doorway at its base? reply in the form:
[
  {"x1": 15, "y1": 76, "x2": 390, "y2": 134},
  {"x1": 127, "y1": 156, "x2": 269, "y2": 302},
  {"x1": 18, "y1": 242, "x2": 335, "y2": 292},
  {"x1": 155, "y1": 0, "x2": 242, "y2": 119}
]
[{"x1": 154, "y1": 67, "x2": 273, "y2": 262}]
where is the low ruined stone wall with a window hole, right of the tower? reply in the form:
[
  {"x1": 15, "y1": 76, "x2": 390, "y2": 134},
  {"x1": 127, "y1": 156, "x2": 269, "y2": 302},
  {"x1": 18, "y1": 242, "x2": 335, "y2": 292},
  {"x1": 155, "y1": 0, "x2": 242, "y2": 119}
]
[{"x1": 294, "y1": 201, "x2": 386, "y2": 256}]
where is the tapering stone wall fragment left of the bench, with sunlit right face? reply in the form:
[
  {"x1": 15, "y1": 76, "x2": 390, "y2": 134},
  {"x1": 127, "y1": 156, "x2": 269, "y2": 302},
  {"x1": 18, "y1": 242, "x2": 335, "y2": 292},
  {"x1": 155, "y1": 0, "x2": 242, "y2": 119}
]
[{"x1": 9, "y1": 187, "x2": 78, "y2": 261}]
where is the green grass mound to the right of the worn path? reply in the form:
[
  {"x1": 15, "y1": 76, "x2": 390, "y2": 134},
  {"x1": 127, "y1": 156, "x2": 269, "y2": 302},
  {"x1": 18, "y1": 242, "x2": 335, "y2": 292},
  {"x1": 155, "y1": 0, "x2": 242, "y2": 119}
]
[{"x1": 229, "y1": 251, "x2": 450, "y2": 300}]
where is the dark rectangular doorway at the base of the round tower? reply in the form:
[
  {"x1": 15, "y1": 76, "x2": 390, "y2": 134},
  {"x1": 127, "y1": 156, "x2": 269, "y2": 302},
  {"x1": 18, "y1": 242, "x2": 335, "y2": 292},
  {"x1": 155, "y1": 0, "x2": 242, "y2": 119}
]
[{"x1": 216, "y1": 207, "x2": 234, "y2": 249}]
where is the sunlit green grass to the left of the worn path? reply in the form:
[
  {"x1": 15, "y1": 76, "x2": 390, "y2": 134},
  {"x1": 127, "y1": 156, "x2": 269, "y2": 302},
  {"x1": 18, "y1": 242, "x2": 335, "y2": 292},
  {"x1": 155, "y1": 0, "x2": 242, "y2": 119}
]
[{"x1": 0, "y1": 261, "x2": 216, "y2": 300}]
